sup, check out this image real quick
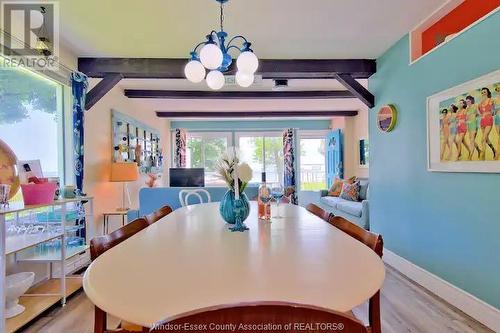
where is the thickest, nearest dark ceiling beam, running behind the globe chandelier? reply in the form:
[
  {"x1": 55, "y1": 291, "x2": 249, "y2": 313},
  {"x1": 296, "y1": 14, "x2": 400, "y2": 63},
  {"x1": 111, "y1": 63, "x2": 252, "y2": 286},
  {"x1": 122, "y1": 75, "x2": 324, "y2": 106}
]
[{"x1": 78, "y1": 58, "x2": 376, "y2": 79}]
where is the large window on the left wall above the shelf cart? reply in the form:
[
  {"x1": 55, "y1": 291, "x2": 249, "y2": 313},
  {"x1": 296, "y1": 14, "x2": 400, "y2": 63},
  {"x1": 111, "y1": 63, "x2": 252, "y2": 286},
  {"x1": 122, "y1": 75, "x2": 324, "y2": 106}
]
[{"x1": 0, "y1": 68, "x2": 64, "y2": 196}]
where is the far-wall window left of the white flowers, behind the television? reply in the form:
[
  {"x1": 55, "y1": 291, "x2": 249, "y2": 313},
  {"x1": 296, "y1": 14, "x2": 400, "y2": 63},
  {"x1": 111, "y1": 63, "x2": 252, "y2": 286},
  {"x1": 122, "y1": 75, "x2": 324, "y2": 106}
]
[{"x1": 186, "y1": 133, "x2": 230, "y2": 186}]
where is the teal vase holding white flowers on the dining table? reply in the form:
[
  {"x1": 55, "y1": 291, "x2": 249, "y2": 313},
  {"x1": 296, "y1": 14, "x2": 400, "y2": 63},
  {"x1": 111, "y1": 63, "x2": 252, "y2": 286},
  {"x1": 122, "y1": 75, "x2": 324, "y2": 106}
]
[{"x1": 215, "y1": 147, "x2": 253, "y2": 231}]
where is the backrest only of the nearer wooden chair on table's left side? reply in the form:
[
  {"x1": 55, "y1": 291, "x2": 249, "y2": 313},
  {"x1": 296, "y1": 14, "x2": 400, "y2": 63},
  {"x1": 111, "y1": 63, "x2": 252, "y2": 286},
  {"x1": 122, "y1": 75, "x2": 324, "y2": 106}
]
[{"x1": 90, "y1": 218, "x2": 149, "y2": 261}]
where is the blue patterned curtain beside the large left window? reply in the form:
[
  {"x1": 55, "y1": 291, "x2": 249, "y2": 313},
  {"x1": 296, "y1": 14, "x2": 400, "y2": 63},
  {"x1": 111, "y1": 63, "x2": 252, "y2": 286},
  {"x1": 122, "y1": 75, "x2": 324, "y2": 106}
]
[{"x1": 71, "y1": 72, "x2": 88, "y2": 194}]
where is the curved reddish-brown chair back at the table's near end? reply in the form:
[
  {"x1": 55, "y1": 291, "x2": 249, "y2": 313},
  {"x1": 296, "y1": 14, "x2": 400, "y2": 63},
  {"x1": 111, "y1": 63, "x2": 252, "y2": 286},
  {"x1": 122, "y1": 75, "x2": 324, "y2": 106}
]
[{"x1": 150, "y1": 302, "x2": 369, "y2": 333}]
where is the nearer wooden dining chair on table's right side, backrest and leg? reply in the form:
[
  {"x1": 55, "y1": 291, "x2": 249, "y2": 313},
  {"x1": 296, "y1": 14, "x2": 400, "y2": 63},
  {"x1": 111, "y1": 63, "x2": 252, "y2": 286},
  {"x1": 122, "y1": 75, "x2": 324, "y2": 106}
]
[{"x1": 329, "y1": 215, "x2": 384, "y2": 333}]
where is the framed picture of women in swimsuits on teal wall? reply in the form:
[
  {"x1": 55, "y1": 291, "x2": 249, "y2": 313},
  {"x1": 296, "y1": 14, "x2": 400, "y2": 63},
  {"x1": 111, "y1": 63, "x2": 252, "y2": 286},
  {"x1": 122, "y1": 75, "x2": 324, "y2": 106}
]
[{"x1": 427, "y1": 70, "x2": 500, "y2": 173}]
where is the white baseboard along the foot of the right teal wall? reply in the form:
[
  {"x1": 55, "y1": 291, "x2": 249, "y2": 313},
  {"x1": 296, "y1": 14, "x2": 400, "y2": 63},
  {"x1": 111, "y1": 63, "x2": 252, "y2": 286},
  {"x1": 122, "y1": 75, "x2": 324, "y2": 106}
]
[{"x1": 383, "y1": 249, "x2": 500, "y2": 332}]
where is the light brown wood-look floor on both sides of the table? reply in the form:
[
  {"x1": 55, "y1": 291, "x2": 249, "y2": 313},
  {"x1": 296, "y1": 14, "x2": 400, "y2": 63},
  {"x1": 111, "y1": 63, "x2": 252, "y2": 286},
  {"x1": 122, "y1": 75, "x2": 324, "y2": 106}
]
[{"x1": 16, "y1": 266, "x2": 493, "y2": 333}]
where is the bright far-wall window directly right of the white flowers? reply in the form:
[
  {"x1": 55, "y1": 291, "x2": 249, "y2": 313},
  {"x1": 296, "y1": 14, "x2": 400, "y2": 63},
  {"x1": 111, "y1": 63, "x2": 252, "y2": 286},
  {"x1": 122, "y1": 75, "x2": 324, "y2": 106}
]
[{"x1": 237, "y1": 133, "x2": 283, "y2": 183}]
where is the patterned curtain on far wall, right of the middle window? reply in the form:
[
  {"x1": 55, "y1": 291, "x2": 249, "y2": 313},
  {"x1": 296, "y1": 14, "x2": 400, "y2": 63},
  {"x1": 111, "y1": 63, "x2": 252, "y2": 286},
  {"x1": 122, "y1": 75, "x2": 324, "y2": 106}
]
[{"x1": 283, "y1": 128, "x2": 298, "y2": 205}]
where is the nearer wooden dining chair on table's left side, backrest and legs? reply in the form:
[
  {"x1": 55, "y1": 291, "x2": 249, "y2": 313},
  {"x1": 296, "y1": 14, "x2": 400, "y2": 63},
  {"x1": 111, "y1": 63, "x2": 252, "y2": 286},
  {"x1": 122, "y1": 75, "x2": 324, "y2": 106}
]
[{"x1": 90, "y1": 218, "x2": 149, "y2": 333}]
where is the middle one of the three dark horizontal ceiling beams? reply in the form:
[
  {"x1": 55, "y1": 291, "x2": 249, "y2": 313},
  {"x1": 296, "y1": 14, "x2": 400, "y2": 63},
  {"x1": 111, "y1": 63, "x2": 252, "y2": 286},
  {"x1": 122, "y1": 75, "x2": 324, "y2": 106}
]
[{"x1": 124, "y1": 89, "x2": 355, "y2": 99}]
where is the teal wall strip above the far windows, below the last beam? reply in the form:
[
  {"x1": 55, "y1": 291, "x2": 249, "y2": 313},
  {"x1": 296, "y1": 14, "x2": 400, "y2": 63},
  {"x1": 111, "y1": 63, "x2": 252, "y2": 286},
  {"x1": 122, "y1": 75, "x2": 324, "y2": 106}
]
[{"x1": 170, "y1": 119, "x2": 330, "y2": 131}]
